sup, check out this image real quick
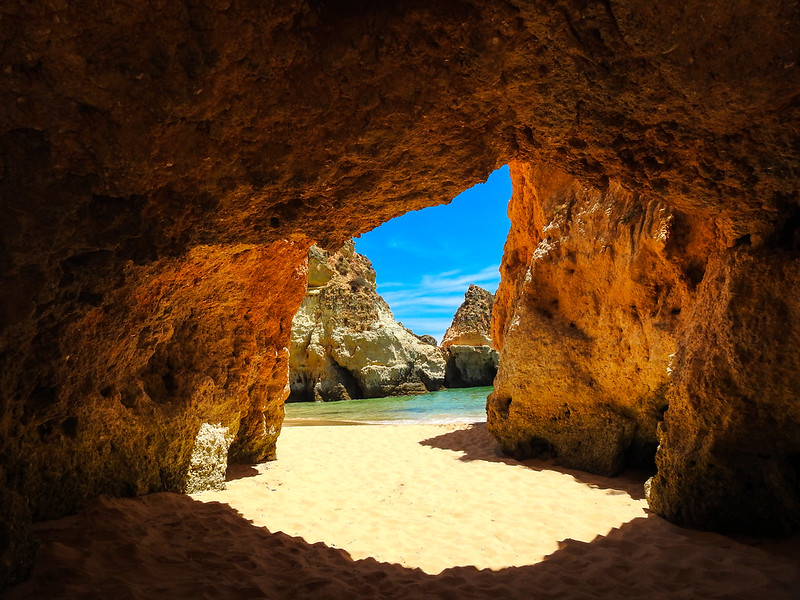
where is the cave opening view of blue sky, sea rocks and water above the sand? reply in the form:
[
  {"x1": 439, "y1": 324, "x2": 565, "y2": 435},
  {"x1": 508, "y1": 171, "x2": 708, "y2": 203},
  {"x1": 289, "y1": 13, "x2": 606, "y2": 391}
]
[{"x1": 286, "y1": 166, "x2": 512, "y2": 408}]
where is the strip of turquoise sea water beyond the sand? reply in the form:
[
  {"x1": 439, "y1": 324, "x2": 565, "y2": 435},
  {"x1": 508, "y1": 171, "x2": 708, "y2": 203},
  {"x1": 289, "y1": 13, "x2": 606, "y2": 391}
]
[{"x1": 284, "y1": 387, "x2": 493, "y2": 426}]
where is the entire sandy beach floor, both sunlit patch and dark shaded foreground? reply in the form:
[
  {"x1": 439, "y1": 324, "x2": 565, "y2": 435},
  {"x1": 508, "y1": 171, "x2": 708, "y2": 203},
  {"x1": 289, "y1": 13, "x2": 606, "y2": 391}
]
[{"x1": 6, "y1": 424, "x2": 800, "y2": 599}]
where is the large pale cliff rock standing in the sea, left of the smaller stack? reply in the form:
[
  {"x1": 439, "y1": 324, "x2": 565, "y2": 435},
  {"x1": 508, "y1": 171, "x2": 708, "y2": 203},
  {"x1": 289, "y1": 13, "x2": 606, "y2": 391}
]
[{"x1": 289, "y1": 241, "x2": 445, "y2": 401}]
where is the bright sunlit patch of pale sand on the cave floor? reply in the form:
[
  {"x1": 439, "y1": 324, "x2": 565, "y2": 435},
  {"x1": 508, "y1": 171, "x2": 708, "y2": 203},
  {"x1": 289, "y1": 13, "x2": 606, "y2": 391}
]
[{"x1": 193, "y1": 425, "x2": 646, "y2": 574}]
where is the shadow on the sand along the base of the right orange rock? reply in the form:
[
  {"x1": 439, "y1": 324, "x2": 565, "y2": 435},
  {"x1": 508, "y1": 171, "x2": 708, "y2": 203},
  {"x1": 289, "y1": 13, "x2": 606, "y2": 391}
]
[{"x1": 420, "y1": 423, "x2": 652, "y2": 500}]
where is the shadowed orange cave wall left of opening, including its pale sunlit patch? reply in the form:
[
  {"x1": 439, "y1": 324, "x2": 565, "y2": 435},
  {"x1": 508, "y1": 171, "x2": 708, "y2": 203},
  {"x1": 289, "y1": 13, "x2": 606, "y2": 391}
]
[{"x1": 0, "y1": 242, "x2": 307, "y2": 580}]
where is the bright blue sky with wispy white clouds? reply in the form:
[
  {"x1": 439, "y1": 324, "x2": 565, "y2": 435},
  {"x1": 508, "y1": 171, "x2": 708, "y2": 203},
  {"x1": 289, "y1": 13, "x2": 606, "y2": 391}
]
[{"x1": 356, "y1": 166, "x2": 511, "y2": 342}]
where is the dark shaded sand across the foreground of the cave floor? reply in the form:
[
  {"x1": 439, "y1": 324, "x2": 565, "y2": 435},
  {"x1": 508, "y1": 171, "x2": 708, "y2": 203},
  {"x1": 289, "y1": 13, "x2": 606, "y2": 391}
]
[{"x1": 4, "y1": 494, "x2": 800, "y2": 600}]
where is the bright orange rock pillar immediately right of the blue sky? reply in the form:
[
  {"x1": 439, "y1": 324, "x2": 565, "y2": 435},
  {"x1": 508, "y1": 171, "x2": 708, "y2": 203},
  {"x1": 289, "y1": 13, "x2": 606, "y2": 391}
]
[{"x1": 488, "y1": 164, "x2": 710, "y2": 474}]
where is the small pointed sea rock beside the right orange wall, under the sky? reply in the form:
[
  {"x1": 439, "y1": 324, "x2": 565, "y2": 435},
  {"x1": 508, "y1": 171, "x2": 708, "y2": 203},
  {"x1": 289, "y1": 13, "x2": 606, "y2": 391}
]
[{"x1": 442, "y1": 284, "x2": 499, "y2": 387}]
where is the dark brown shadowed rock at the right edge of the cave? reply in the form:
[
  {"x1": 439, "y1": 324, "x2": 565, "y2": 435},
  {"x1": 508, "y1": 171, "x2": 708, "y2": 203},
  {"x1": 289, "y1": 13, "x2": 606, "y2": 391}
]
[{"x1": 648, "y1": 250, "x2": 800, "y2": 534}]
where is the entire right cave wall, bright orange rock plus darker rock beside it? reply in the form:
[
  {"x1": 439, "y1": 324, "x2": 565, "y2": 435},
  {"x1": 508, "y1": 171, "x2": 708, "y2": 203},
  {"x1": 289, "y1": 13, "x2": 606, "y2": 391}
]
[{"x1": 487, "y1": 159, "x2": 800, "y2": 533}]
